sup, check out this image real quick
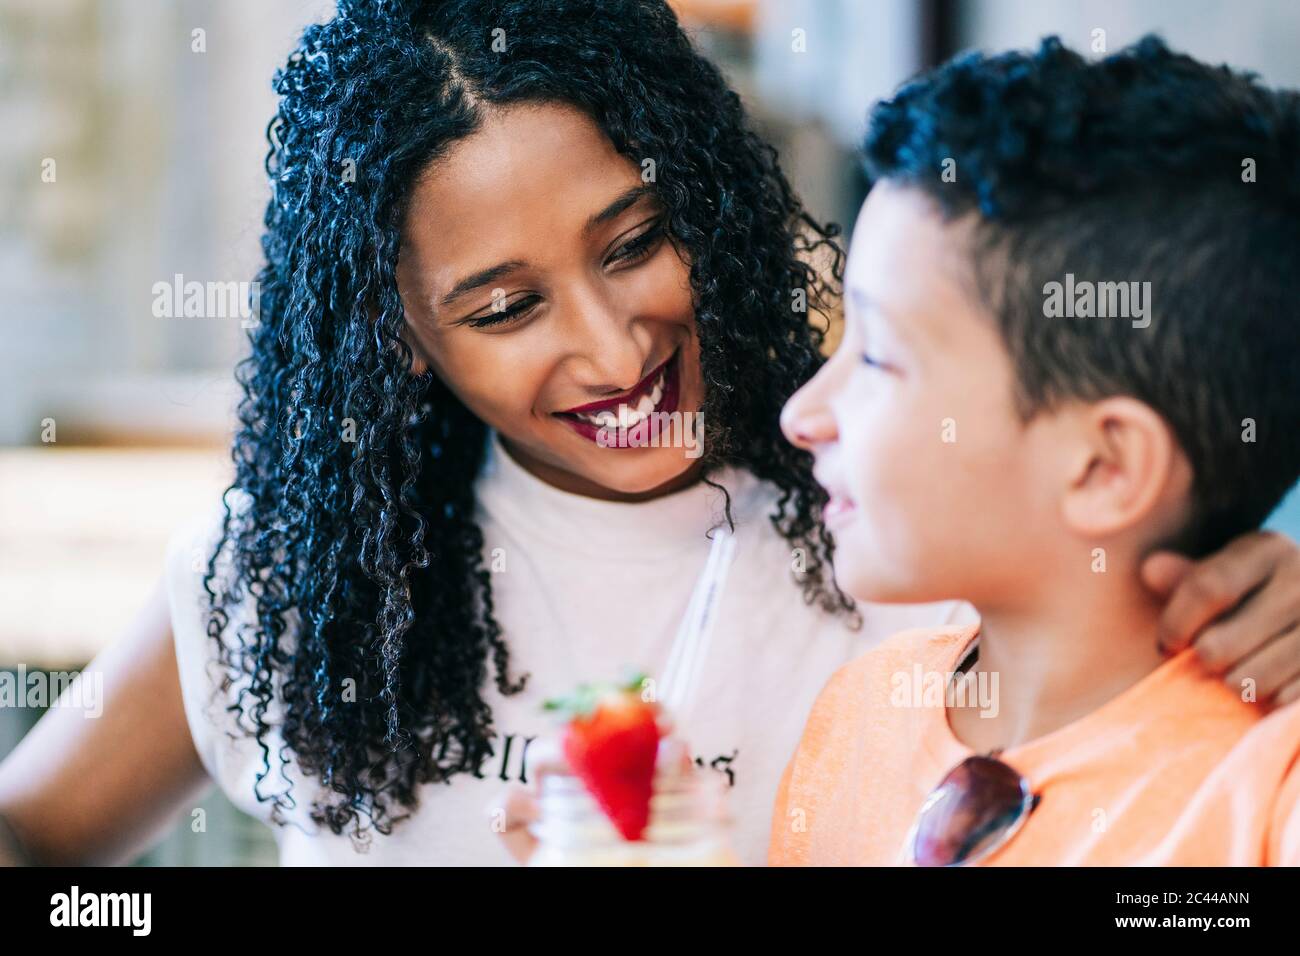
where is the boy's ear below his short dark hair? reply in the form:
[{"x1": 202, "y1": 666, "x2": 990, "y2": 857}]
[{"x1": 1061, "y1": 397, "x2": 1191, "y2": 538}]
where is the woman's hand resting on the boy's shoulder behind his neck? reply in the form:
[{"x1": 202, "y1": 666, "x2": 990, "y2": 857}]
[{"x1": 1141, "y1": 531, "x2": 1300, "y2": 706}]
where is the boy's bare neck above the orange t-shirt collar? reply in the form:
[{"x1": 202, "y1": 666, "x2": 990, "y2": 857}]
[{"x1": 948, "y1": 568, "x2": 1164, "y2": 753}]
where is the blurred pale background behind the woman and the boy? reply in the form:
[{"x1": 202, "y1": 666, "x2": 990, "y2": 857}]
[{"x1": 0, "y1": 0, "x2": 1300, "y2": 864}]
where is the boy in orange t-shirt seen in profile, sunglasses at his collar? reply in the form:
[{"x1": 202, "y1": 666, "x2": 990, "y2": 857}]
[{"x1": 770, "y1": 38, "x2": 1300, "y2": 865}]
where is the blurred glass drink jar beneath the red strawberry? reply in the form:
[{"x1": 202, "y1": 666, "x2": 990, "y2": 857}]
[{"x1": 529, "y1": 771, "x2": 740, "y2": 866}]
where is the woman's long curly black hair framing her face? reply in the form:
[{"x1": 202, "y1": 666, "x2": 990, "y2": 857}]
[{"x1": 204, "y1": 0, "x2": 857, "y2": 839}]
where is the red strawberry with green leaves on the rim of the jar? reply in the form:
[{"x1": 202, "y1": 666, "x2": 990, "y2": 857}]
[{"x1": 545, "y1": 676, "x2": 662, "y2": 840}]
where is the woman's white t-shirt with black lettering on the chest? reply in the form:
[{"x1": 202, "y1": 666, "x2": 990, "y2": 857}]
[{"x1": 166, "y1": 434, "x2": 974, "y2": 865}]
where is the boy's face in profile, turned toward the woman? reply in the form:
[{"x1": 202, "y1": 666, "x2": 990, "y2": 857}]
[{"x1": 781, "y1": 183, "x2": 1060, "y2": 601}]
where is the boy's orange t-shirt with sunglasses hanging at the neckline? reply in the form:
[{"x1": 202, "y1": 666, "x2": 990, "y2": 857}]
[{"x1": 768, "y1": 627, "x2": 1300, "y2": 866}]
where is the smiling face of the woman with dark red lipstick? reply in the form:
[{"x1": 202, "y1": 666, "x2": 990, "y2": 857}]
[{"x1": 398, "y1": 104, "x2": 703, "y2": 499}]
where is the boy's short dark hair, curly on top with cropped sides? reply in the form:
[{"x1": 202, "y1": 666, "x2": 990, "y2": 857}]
[{"x1": 865, "y1": 36, "x2": 1300, "y2": 553}]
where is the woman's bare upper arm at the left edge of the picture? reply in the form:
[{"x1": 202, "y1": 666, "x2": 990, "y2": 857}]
[{"x1": 0, "y1": 574, "x2": 208, "y2": 865}]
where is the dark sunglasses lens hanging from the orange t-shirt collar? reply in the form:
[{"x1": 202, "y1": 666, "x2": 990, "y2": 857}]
[{"x1": 913, "y1": 757, "x2": 1026, "y2": 866}]
